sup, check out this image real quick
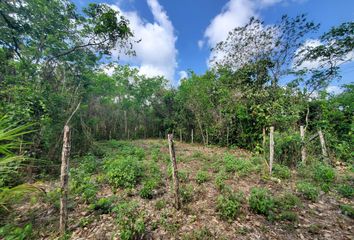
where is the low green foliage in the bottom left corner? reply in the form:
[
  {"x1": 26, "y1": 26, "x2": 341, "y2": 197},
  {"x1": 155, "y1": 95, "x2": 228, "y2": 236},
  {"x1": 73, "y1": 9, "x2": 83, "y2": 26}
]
[{"x1": 0, "y1": 224, "x2": 32, "y2": 240}]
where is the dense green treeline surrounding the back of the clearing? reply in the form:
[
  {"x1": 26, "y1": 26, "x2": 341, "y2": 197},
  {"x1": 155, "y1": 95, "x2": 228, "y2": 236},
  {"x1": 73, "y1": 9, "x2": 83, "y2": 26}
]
[{"x1": 0, "y1": 0, "x2": 354, "y2": 186}]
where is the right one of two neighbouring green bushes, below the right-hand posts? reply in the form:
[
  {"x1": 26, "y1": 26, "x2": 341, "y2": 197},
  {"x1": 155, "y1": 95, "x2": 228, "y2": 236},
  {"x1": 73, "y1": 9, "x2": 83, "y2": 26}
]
[{"x1": 249, "y1": 188, "x2": 274, "y2": 216}]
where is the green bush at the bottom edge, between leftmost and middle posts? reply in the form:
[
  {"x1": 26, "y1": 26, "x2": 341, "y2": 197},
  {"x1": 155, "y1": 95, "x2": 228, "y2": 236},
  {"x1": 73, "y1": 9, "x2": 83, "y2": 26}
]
[{"x1": 113, "y1": 202, "x2": 145, "y2": 240}]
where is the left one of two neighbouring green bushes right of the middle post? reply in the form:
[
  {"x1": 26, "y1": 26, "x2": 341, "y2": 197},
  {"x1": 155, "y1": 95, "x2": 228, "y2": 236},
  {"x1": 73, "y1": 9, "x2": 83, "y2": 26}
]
[{"x1": 216, "y1": 192, "x2": 243, "y2": 220}]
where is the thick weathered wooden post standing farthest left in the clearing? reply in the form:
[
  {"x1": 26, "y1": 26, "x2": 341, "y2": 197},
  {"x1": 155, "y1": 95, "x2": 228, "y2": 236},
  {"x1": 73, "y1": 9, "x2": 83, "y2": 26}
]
[{"x1": 59, "y1": 125, "x2": 70, "y2": 234}]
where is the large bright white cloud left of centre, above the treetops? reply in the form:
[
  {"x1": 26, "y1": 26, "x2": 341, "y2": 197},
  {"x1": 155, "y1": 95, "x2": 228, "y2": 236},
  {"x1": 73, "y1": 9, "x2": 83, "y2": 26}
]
[{"x1": 111, "y1": 0, "x2": 178, "y2": 81}]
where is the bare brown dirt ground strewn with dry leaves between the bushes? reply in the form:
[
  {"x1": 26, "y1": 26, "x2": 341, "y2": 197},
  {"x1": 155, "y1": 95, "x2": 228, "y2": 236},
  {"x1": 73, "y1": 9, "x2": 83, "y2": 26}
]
[{"x1": 9, "y1": 140, "x2": 354, "y2": 240}]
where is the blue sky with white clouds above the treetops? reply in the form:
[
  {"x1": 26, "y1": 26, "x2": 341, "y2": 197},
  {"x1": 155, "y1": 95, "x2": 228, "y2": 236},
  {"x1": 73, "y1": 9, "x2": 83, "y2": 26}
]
[{"x1": 74, "y1": 0, "x2": 354, "y2": 90}]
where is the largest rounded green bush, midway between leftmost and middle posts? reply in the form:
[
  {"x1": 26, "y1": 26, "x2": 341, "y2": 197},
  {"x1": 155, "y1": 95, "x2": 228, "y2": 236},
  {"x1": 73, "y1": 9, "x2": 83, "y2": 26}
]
[{"x1": 104, "y1": 156, "x2": 142, "y2": 188}]
